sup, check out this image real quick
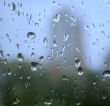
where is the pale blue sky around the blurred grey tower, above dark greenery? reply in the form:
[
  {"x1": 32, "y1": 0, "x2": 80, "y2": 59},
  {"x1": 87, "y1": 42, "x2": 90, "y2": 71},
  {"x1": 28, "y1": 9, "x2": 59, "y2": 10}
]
[{"x1": 0, "y1": 0, "x2": 110, "y2": 70}]
